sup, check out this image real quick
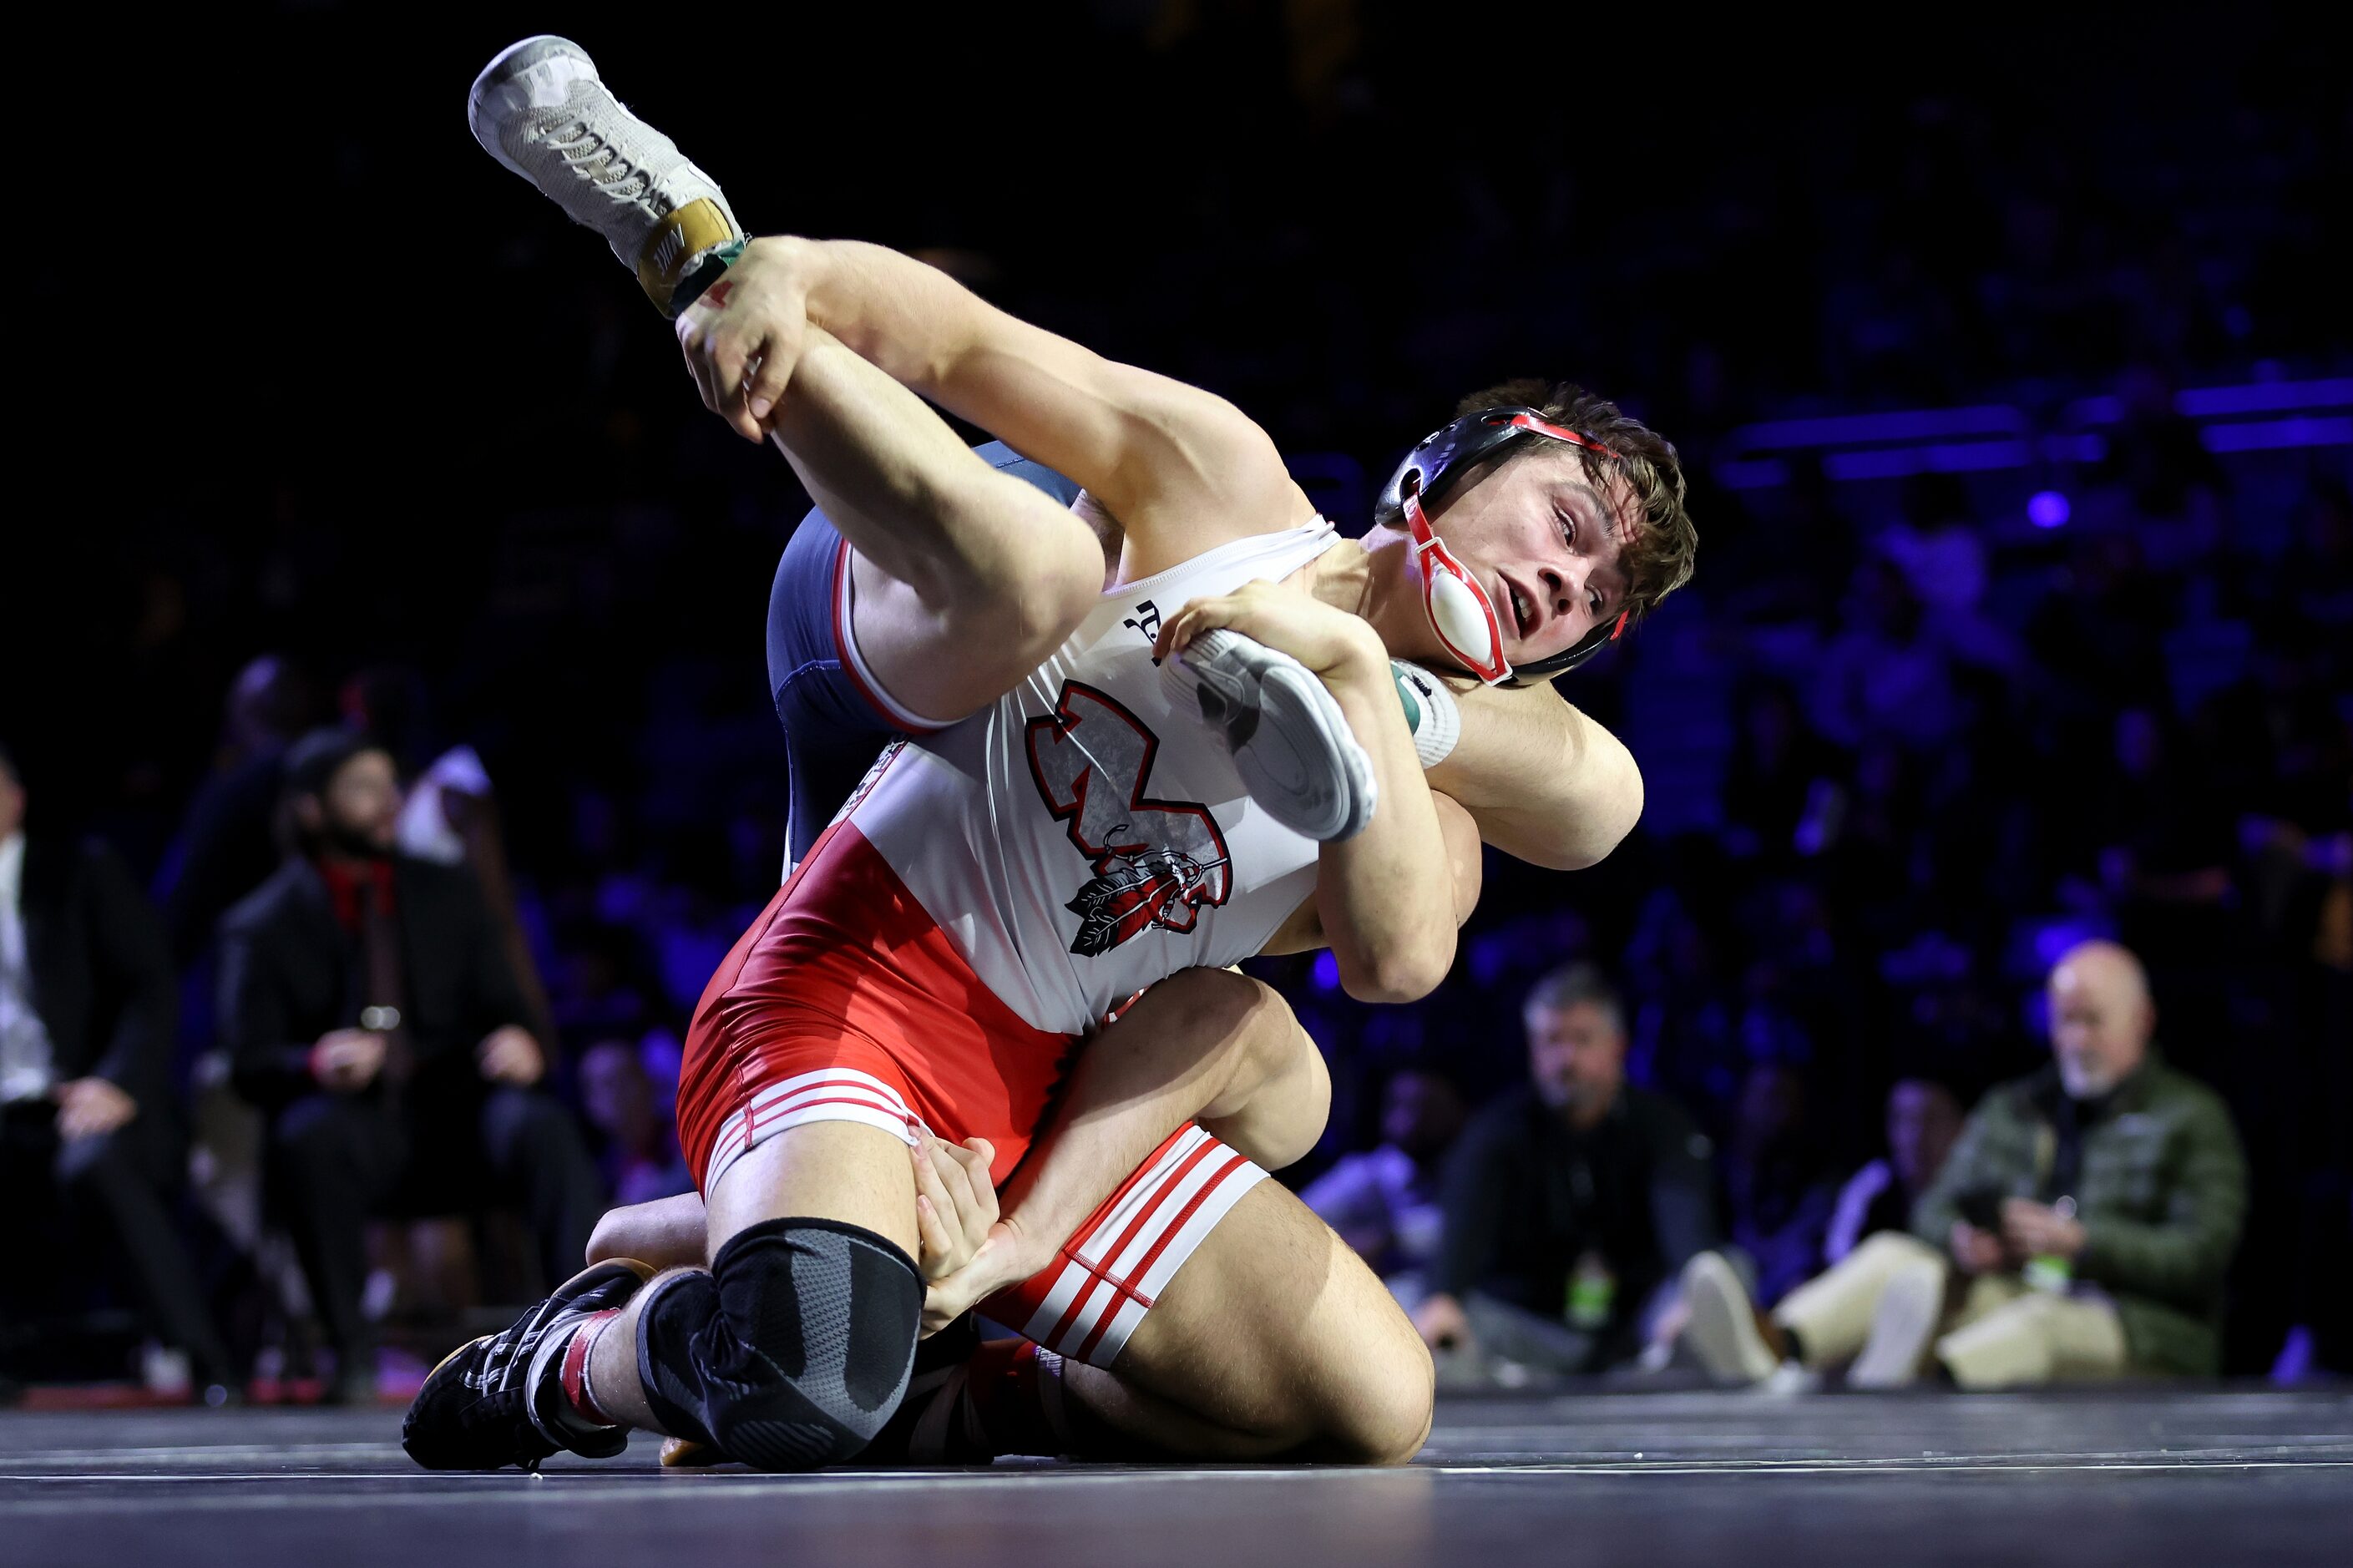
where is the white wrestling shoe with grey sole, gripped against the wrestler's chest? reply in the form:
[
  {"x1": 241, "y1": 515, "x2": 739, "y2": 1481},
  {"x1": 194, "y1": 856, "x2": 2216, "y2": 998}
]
[{"x1": 1160, "y1": 629, "x2": 1377, "y2": 841}]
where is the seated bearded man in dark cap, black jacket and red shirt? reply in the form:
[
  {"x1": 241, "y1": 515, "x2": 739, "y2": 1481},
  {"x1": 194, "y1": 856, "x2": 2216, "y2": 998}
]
[{"x1": 221, "y1": 730, "x2": 602, "y2": 1399}]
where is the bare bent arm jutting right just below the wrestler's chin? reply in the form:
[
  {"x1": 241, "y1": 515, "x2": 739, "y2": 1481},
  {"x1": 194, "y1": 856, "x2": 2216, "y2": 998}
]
[{"x1": 1429, "y1": 685, "x2": 1642, "y2": 871}]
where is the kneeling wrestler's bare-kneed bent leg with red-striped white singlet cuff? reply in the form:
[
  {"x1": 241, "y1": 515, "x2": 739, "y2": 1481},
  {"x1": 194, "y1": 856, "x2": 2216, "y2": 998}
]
[{"x1": 927, "y1": 1172, "x2": 1433, "y2": 1464}]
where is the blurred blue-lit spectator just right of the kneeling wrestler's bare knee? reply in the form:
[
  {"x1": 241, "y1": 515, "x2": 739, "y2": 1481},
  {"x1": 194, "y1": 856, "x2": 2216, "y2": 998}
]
[{"x1": 1299, "y1": 1066, "x2": 1464, "y2": 1309}]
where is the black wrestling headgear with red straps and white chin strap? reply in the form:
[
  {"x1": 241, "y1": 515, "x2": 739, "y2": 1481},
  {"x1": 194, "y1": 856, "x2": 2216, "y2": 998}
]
[{"x1": 1372, "y1": 407, "x2": 1626, "y2": 685}]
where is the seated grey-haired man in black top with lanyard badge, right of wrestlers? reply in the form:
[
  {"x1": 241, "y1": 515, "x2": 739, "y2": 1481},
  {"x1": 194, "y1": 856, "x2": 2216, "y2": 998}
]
[{"x1": 1414, "y1": 963, "x2": 1718, "y2": 1373}]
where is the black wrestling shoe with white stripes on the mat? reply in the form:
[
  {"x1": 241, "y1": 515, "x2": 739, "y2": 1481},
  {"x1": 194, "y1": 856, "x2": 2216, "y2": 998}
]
[{"x1": 400, "y1": 1257, "x2": 654, "y2": 1469}]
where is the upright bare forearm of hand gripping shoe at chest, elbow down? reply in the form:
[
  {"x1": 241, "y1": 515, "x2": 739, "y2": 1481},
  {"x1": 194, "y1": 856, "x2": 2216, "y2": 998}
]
[{"x1": 1315, "y1": 660, "x2": 1455, "y2": 1003}]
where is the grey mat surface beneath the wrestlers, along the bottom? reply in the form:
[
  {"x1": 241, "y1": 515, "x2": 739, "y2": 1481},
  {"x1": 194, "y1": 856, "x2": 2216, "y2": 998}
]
[{"x1": 0, "y1": 1392, "x2": 2353, "y2": 1568}]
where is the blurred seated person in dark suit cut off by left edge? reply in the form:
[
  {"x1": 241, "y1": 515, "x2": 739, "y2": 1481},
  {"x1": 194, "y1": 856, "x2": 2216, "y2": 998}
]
[{"x1": 0, "y1": 751, "x2": 235, "y2": 1389}]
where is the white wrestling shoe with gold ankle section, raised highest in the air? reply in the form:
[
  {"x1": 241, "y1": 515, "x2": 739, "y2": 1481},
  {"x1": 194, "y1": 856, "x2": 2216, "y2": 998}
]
[{"x1": 466, "y1": 35, "x2": 743, "y2": 316}]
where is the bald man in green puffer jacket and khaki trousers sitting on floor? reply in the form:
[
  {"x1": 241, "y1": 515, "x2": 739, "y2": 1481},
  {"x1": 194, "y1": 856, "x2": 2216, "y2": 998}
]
[{"x1": 1685, "y1": 942, "x2": 2247, "y2": 1389}]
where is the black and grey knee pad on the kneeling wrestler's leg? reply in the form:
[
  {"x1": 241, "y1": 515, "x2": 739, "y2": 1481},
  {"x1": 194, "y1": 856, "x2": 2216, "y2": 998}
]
[{"x1": 638, "y1": 1220, "x2": 923, "y2": 1469}]
